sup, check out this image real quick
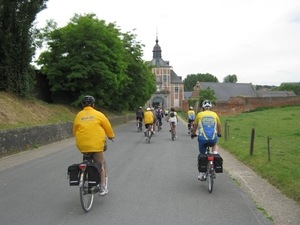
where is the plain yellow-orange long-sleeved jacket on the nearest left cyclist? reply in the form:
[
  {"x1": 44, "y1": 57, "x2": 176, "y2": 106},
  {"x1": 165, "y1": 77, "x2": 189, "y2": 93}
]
[{"x1": 73, "y1": 106, "x2": 115, "y2": 152}]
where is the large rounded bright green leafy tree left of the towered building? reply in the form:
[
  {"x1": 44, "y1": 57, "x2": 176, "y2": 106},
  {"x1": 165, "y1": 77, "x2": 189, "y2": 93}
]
[{"x1": 37, "y1": 14, "x2": 155, "y2": 111}]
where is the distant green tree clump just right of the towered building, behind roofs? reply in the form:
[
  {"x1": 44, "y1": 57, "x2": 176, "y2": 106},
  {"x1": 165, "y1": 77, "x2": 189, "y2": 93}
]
[{"x1": 183, "y1": 73, "x2": 219, "y2": 91}]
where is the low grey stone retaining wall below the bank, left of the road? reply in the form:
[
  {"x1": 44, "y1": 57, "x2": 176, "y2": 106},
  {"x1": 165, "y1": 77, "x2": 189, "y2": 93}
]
[{"x1": 0, "y1": 114, "x2": 136, "y2": 157}]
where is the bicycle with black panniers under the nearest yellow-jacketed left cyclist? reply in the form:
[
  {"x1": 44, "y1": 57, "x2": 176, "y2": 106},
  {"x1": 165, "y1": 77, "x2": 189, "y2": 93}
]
[{"x1": 68, "y1": 140, "x2": 109, "y2": 212}]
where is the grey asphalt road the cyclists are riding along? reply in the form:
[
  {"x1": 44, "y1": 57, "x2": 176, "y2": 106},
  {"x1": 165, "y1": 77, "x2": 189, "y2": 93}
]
[{"x1": 0, "y1": 118, "x2": 272, "y2": 225}]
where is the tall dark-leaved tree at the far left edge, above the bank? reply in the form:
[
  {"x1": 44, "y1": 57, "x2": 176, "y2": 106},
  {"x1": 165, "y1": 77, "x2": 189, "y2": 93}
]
[{"x1": 0, "y1": 0, "x2": 48, "y2": 97}]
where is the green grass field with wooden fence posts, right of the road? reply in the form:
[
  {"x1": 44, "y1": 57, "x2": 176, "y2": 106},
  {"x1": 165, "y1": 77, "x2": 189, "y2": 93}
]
[{"x1": 219, "y1": 106, "x2": 300, "y2": 204}]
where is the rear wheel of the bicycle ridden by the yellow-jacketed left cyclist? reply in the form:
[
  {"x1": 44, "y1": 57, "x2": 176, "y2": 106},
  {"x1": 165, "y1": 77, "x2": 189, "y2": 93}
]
[{"x1": 79, "y1": 173, "x2": 94, "y2": 212}]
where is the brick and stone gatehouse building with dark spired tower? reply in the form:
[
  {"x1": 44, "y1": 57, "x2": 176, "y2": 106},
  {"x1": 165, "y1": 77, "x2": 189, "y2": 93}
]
[{"x1": 146, "y1": 36, "x2": 184, "y2": 110}]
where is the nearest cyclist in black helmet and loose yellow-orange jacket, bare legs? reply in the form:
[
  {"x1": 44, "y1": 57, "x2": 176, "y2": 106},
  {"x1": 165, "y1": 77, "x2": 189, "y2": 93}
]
[{"x1": 73, "y1": 95, "x2": 115, "y2": 196}]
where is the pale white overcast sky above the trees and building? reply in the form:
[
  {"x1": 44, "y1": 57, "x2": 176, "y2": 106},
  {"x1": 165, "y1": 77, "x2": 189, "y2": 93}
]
[{"x1": 36, "y1": 0, "x2": 300, "y2": 86}]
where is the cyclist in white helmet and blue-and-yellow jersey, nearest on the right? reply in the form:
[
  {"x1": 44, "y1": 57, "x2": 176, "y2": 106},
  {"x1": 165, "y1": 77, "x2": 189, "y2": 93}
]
[{"x1": 191, "y1": 100, "x2": 221, "y2": 181}]
